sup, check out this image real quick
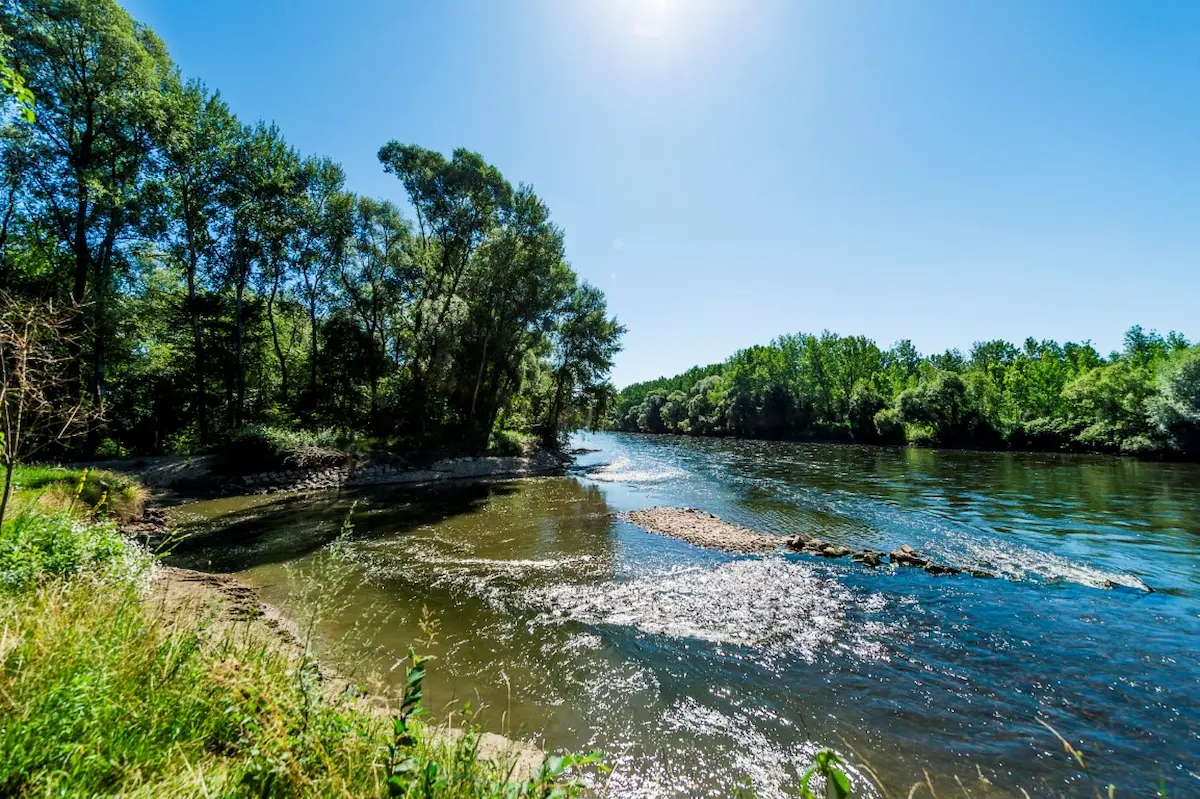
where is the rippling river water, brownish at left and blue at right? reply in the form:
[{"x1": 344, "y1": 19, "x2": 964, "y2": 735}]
[{"x1": 173, "y1": 433, "x2": 1200, "y2": 797}]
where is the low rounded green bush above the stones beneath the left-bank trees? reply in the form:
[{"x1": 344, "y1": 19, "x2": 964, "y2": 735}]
[{"x1": 216, "y1": 425, "x2": 353, "y2": 474}]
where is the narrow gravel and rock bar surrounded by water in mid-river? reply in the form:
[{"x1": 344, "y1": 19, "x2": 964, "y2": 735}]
[{"x1": 624, "y1": 507, "x2": 994, "y2": 577}]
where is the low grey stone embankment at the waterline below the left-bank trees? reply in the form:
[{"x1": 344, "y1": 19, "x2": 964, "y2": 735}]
[{"x1": 241, "y1": 452, "x2": 565, "y2": 494}]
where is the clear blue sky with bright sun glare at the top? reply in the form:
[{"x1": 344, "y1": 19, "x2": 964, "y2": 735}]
[{"x1": 125, "y1": 0, "x2": 1200, "y2": 386}]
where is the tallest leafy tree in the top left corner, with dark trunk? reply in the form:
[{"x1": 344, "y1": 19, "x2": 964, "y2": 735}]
[{"x1": 4, "y1": 0, "x2": 173, "y2": 405}]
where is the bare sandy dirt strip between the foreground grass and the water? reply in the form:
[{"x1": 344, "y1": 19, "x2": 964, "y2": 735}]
[{"x1": 146, "y1": 566, "x2": 545, "y2": 781}]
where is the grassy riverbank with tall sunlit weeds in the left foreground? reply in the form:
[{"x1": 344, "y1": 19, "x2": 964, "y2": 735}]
[{"x1": 0, "y1": 463, "x2": 597, "y2": 799}]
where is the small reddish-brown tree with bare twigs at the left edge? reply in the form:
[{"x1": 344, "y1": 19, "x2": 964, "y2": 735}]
[{"x1": 0, "y1": 294, "x2": 86, "y2": 523}]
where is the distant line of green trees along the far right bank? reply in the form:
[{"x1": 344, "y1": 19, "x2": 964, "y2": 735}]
[{"x1": 608, "y1": 326, "x2": 1200, "y2": 457}]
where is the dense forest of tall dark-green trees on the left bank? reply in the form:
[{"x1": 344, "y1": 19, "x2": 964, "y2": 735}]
[{"x1": 0, "y1": 0, "x2": 623, "y2": 456}]
